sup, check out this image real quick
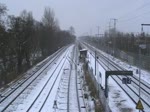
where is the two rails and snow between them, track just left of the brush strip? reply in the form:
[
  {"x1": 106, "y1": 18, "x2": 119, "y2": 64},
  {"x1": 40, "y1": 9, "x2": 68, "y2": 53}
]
[{"x1": 67, "y1": 47, "x2": 81, "y2": 112}]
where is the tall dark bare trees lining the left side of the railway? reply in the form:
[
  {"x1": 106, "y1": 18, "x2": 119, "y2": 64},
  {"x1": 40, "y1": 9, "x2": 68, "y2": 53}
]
[{"x1": 0, "y1": 4, "x2": 76, "y2": 85}]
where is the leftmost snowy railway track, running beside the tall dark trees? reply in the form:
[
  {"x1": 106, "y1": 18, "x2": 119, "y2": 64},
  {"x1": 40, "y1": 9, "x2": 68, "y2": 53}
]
[{"x1": 0, "y1": 47, "x2": 69, "y2": 112}]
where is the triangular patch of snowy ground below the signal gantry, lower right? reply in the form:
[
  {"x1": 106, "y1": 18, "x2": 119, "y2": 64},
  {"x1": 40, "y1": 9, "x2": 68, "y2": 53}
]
[{"x1": 108, "y1": 78, "x2": 139, "y2": 112}]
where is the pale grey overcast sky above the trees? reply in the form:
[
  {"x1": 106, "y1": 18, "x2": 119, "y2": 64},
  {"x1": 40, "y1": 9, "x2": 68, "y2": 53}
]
[{"x1": 0, "y1": 0, "x2": 150, "y2": 36}]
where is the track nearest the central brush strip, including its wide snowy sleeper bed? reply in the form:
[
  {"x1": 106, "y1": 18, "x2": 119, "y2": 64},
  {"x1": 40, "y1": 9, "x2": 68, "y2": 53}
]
[{"x1": 55, "y1": 46, "x2": 87, "y2": 112}]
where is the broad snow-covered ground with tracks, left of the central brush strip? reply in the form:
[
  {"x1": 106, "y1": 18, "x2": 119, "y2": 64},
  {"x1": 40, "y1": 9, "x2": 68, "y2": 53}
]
[{"x1": 0, "y1": 45, "x2": 85, "y2": 112}]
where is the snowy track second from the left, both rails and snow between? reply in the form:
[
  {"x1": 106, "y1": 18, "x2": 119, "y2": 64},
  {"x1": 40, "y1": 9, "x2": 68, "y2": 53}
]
[{"x1": 27, "y1": 47, "x2": 68, "y2": 112}]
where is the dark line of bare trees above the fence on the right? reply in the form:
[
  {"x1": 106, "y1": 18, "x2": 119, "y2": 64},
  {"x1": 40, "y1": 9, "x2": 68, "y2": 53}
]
[{"x1": 80, "y1": 29, "x2": 150, "y2": 55}]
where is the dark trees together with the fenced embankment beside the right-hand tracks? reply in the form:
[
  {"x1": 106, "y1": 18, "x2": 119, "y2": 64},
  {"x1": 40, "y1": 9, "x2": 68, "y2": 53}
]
[{"x1": 80, "y1": 29, "x2": 150, "y2": 70}]
